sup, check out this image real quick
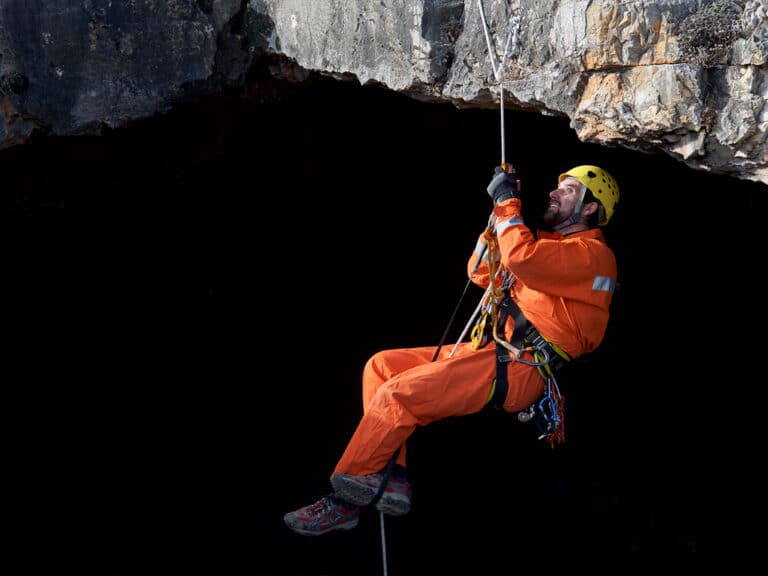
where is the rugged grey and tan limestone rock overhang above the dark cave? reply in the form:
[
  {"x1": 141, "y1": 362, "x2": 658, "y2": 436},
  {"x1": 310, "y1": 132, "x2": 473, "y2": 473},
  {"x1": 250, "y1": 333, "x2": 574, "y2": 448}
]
[{"x1": 0, "y1": 0, "x2": 768, "y2": 184}]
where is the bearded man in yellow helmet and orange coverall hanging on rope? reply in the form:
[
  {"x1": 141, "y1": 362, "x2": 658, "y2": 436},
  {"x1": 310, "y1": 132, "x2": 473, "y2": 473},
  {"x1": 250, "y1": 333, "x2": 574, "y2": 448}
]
[{"x1": 284, "y1": 165, "x2": 619, "y2": 535}]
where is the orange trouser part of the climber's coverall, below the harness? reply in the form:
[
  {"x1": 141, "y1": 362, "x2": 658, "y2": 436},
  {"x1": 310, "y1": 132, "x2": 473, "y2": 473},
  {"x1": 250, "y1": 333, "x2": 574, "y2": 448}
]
[{"x1": 333, "y1": 342, "x2": 543, "y2": 475}]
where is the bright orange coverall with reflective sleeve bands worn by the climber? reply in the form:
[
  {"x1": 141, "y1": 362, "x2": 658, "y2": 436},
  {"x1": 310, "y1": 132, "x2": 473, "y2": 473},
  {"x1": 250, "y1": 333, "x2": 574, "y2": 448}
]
[{"x1": 333, "y1": 198, "x2": 617, "y2": 475}]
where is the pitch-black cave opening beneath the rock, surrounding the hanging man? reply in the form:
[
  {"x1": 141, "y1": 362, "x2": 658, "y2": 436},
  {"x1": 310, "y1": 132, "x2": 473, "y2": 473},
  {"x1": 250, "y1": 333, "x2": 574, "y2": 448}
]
[{"x1": 0, "y1": 73, "x2": 766, "y2": 576}]
